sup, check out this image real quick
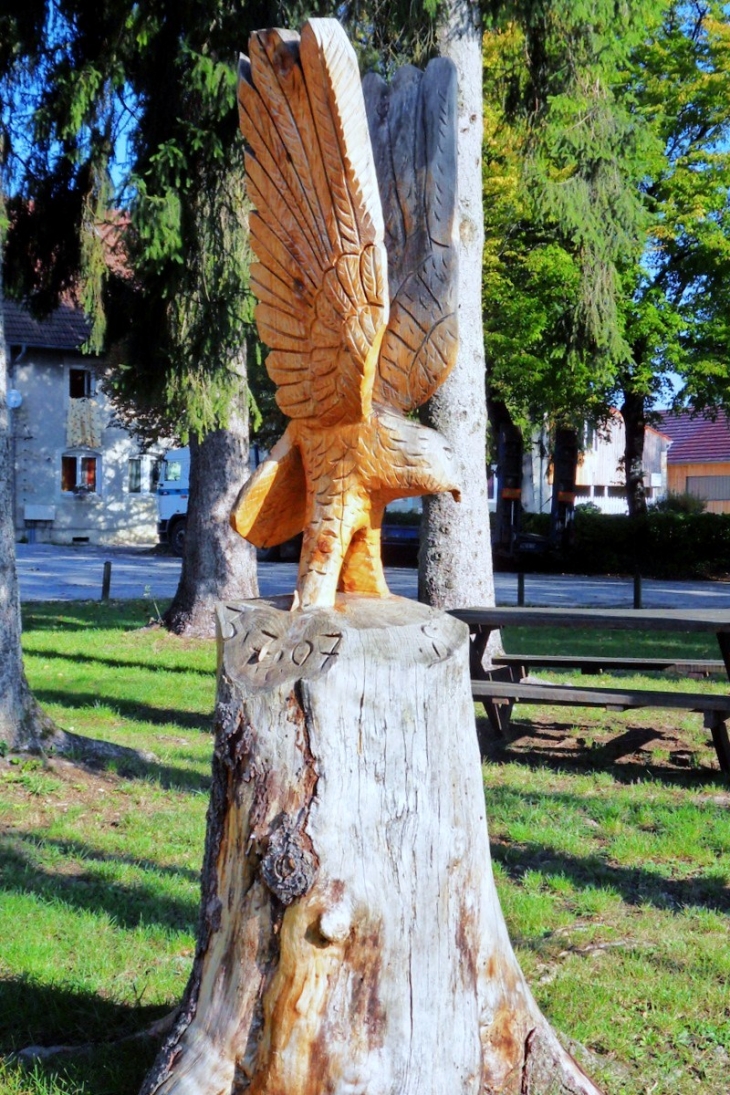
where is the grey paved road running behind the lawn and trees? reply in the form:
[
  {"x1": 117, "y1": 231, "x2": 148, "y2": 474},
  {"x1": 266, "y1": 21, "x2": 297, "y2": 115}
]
[{"x1": 16, "y1": 544, "x2": 730, "y2": 609}]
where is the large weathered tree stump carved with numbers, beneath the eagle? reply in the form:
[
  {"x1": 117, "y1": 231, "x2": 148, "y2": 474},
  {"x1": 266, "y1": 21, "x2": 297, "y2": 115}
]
[{"x1": 142, "y1": 597, "x2": 598, "y2": 1095}]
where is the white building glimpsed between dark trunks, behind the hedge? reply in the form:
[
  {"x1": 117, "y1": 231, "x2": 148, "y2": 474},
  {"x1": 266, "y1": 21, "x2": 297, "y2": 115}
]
[{"x1": 522, "y1": 411, "x2": 670, "y2": 514}]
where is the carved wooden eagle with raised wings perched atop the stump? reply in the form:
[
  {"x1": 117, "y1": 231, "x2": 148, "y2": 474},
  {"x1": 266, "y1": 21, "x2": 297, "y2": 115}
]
[{"x1": 231, "y1": 19, "x2": 459, "y2": 609}]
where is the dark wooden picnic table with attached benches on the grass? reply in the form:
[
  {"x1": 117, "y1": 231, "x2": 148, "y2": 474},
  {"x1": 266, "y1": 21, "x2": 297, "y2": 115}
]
[{"x1": 452, "y1": 606, "x2": 730, "y2": 776}]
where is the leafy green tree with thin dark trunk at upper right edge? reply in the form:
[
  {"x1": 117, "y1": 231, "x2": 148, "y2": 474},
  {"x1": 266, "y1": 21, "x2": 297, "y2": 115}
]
[{"x1": 616, "y1": 2, "x2": 730, "y2": 512}]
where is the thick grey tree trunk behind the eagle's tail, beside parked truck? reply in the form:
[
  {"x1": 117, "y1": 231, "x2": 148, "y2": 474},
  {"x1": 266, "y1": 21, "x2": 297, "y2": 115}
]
[{"x1": 164, "y1": 361, "x2": 258, "y2": 637}]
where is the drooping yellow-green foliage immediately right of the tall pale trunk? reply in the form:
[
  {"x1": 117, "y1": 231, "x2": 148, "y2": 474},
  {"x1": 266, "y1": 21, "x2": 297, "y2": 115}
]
[{"x1": 484, "y1": 0, "x2": 661, "y2": 435}]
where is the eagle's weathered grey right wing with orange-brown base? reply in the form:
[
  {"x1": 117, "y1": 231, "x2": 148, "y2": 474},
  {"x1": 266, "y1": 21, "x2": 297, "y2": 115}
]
[{"x1": 363, "y1": 58, "x2": 457, "y2": 412}]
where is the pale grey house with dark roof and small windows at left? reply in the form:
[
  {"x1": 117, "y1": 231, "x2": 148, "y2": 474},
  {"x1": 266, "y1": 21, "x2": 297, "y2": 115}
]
[{"x1": 2, "y1": 300, "x2": 162, "y2": 544}]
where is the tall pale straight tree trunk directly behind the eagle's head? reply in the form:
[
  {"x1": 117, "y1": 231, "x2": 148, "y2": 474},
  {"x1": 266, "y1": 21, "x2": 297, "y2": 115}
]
[{"x1": 418, "y1": 0, "x2": 495, "y2": 608}]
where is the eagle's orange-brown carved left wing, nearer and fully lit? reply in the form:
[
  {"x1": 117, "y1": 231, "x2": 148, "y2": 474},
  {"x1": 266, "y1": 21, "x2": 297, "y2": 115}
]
[{"x1": 239, "y1": 19, "x2": 389, "y2": 426}]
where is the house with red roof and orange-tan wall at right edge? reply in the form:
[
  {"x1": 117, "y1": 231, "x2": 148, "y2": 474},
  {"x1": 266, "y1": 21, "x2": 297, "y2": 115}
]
[{"x1": 662, "y1": 412, "x2": 730, "y2": 514}]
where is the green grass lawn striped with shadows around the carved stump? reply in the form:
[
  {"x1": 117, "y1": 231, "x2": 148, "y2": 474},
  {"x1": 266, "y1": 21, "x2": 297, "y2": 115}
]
[{"x1": 0, "y1": 601, "x2": 730, "y2": 1095}]
